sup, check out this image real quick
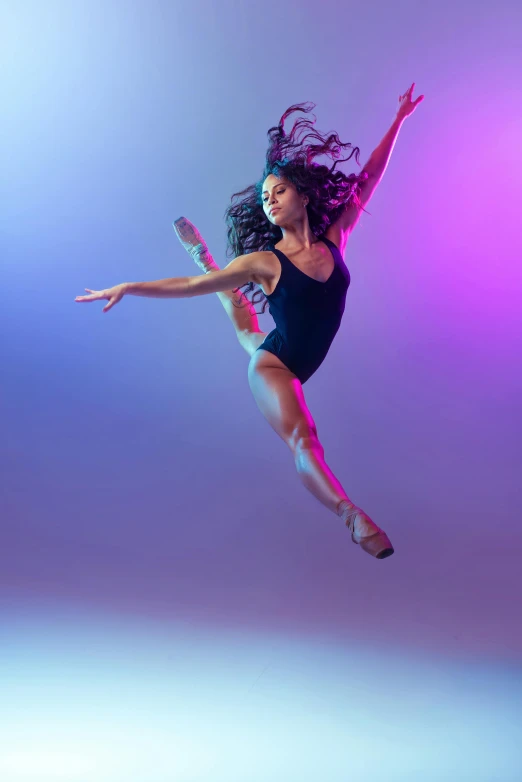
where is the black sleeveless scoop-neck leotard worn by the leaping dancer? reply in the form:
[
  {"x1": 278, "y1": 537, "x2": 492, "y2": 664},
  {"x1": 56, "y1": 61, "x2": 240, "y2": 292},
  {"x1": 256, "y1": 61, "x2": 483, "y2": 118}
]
[{"x1": 258, "y1": 236, "x2": 350, "y2": 383}]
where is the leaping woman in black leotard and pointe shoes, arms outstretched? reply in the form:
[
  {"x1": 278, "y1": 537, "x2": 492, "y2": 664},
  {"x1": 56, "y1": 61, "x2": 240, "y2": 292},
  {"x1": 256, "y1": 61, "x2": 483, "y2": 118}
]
[{"x1": 76, "y1": 84, "x2": 424, "y2": 559}]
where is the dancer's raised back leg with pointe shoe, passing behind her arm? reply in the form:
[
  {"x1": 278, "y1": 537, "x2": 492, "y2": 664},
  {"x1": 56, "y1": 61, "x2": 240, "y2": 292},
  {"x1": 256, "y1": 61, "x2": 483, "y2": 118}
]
[{"x1": 173, "y1": 217, "x2": 266, "y2": 356}]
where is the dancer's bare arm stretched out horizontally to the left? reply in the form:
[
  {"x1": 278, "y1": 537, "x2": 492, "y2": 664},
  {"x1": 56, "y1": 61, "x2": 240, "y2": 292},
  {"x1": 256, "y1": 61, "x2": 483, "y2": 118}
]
[{"x1": 76, "y1": 252, "x2": 266, "y2": 312}]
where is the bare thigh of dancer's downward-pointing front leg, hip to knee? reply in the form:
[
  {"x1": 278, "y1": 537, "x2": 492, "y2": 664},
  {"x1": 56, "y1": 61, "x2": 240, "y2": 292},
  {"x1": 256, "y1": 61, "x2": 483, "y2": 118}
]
[{"x1": 248, "y1": 350, "x2": 317, "y2": 448}]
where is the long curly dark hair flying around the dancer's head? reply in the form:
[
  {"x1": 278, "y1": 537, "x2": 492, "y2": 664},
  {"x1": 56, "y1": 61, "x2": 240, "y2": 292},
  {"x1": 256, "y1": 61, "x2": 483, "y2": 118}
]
[{"x1": 225, "y1": 103, "x2": 368, "y2": 314}]
